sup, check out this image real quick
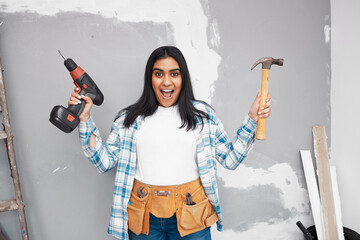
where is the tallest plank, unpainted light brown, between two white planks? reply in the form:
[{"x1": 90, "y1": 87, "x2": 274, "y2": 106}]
[{"x1": 313, "y1": 126, "x2": 338, "y2": 240}]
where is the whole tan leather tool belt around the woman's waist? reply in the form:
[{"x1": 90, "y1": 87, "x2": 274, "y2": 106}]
[{"x1": 127, "y1": 178, "x2": 218, "y2": 236}]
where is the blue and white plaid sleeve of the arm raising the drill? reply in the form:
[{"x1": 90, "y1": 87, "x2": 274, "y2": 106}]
[{"x1": 79, "y1": 117, "x2": 120, "y2": 173}]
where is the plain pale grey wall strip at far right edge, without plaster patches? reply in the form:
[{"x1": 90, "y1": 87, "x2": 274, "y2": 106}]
[{"x1": 331, "y1": 0, "x2": 360, "y2": 232}]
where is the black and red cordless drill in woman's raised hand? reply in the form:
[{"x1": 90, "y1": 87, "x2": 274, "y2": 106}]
[{"x1": 49, "y1": 50, "x2": 104, "y2": 133}]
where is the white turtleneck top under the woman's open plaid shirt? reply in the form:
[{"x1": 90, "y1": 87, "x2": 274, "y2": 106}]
[{"x1": 135, "y1": 105, "x2": 199, "y2": 186}]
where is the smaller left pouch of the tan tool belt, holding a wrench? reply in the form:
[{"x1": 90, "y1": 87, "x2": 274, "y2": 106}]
[{"x1": 127, "y1": 192, "x2": 149, "y2": 235}]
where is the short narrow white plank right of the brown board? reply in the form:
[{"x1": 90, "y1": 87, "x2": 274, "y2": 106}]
[{"x1": 330, "y1": 166, "x2": 345, "y2": 240}]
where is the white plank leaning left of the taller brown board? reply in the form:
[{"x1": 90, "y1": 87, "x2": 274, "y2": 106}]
[{"x1": 300, "y1": 150, "x2": 324, "y2": 240}]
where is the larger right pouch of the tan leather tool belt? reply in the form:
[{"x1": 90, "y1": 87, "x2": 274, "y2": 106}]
[{"x1": 178, "y1": 187, "x2": 218, "y2": 236}]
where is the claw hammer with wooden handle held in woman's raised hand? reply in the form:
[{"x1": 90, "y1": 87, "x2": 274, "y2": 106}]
[{"x1": 251, "y1": 57, "x2": 284, "y2": 140}]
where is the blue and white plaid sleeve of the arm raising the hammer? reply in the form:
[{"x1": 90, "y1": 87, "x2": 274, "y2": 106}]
[{"x1": 215, "y1": 116, "x2": 257, "y2": 170}]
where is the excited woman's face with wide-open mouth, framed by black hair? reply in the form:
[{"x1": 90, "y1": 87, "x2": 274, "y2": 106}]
[{"x1": 152, "y1": 57, "x2": 182, "y2": 107}]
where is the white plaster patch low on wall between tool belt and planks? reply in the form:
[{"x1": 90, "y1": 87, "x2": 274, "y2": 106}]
[{"x1": 217, "y1": 158, "x2": 314, "y2": 240}]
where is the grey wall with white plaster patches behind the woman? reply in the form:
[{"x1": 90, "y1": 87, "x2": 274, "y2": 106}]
[{"x1": 0, "y1": 0, "x2": 330, "y2": 240}]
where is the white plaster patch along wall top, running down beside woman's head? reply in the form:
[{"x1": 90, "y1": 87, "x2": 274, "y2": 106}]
[{"x1": 0, "y1": 0, "x2": 221, "y2": 103}]
